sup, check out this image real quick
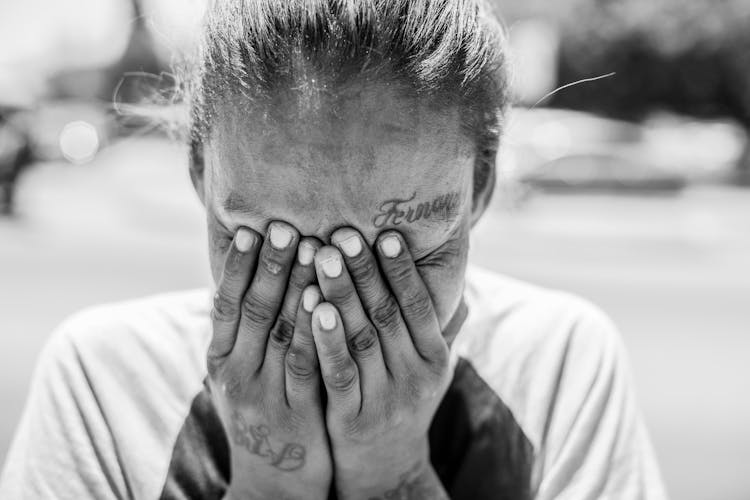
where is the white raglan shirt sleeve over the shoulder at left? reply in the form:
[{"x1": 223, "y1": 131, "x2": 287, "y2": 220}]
[{"x1": 0, "y1": 290, "x2": 210, "y2": 498}]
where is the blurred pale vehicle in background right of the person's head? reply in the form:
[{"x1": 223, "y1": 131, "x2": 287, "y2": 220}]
[{"x1": 500, "y1": 108, "x2": 748, "y2": 193}]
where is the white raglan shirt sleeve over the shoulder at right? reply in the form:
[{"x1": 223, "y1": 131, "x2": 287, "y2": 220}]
[{"x1": 453, "y1": 268, "x2": 663, "y2": 498}]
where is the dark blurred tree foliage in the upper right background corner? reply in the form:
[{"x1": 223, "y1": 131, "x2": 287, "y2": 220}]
[{"x1": 494, "y1": 0, "x2": 750, "y2": 179}]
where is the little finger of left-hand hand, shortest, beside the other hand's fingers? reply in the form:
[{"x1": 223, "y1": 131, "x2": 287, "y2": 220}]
[{"x1": 284, "y1": 285, "x2": 321, "y2": 408}]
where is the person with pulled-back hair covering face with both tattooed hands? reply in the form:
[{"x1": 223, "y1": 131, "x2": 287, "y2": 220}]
[{"x1": 0, "y1": 0, "x2": 664, "y2": 499}]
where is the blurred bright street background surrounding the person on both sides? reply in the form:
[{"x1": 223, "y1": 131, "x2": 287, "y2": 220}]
[{"x1": 0, "y1": 0, "x2": 750, "y2": 500}]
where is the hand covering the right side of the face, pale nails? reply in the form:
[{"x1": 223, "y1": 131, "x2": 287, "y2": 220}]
[{"x1": 312, "y1": 229, "x2": 450, "y2": 499}]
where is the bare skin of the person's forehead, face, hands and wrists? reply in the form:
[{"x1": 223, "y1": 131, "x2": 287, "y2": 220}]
[{"x1": 192, "y1": 85, "x2": 500, "y2": 498}]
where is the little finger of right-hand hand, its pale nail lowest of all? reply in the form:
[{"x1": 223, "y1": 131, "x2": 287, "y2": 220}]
[{"x1": 311, "y1": 302, "x2": 362, "y2": 414}]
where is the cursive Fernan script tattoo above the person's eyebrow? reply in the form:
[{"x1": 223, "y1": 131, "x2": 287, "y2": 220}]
[{"x1": 372, "y1": 191, "x2": 461, "y2": 229}]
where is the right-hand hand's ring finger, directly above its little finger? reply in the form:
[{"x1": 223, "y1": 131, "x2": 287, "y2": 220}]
[{"x1": 315, "y1": 246, "x2": 386, "y2": 397}]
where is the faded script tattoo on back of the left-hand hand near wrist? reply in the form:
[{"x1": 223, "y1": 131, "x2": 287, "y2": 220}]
[{"x1": 232, "y1": 412, "x2": 305, "y2": 471}]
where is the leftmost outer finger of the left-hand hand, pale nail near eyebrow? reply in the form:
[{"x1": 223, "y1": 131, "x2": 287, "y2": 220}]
[{"x1": 208, "y1": 227, "x2": 261, "y2": 360}]
